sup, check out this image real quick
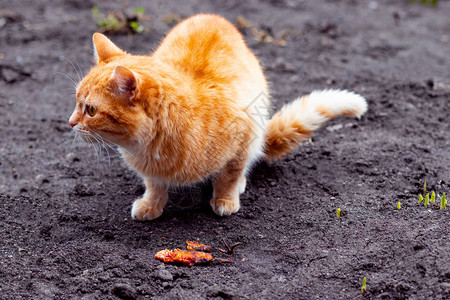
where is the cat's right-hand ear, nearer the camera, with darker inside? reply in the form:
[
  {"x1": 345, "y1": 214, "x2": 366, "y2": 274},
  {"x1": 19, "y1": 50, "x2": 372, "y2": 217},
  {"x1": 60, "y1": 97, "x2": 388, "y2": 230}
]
[{"x1": 108, "y1": 66, "x2": 137, "y2": 102}]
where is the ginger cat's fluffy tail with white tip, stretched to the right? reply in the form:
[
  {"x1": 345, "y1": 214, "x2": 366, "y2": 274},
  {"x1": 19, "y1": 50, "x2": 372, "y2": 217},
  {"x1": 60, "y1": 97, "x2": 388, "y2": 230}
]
[{"x1": 264, "y1": 90, "x2": 367, "y2": 160}]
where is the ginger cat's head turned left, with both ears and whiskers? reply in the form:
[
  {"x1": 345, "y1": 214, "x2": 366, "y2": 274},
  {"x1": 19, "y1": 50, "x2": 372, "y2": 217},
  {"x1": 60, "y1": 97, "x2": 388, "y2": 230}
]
[{"x1": 69, "y1": 33, "x2": 153, "y2": 147}]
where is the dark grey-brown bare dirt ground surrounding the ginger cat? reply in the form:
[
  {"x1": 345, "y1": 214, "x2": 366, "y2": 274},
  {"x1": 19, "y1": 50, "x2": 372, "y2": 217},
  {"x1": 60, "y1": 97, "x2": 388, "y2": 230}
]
[{"x1": 0, "y1": 0, "x2": 450, "y2": 299}]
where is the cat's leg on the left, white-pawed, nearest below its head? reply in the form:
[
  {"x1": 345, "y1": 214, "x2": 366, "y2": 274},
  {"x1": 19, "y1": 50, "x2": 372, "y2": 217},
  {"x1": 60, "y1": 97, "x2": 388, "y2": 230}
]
[{"x1": 131, "y1": 178, "x2": 168, "y2": 221}]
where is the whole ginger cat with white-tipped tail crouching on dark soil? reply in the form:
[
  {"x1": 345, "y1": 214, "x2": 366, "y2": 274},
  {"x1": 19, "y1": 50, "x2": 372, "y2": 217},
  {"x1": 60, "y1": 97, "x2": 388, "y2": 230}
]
[{"x1": 69, "y1": 15, "x2": 367, "y2": 221}]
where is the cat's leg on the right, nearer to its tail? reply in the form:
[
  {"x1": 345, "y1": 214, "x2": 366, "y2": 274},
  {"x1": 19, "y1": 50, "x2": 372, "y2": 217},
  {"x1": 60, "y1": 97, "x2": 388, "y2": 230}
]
[{"x1": 210, "y1": 158, "x2": 246, "y2": 216}]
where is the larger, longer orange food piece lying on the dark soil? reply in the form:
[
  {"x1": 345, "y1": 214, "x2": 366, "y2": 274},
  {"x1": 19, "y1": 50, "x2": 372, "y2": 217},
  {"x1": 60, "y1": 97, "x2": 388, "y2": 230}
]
[{"x1": 155, "y1": 249, "x2": 213, "y2": 267}]
